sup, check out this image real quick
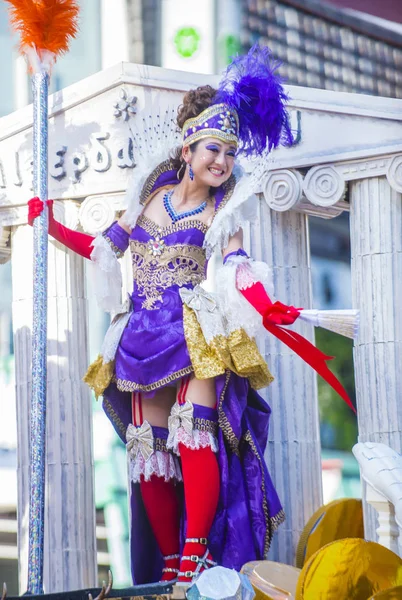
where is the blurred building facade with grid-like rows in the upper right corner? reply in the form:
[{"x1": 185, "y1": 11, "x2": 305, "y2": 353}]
[{"x1": 242, "y1": 0, "x2": 402, "y2": 98}]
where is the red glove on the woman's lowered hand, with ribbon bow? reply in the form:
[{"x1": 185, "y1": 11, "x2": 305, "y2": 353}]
[{"x1": 239, "y1": 281, "x2": 301, "y2": 325}]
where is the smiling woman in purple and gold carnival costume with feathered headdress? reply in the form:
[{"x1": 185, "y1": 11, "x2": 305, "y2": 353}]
[{"x1": 29, "y1": 46, "x2": 348, "y2": 583}]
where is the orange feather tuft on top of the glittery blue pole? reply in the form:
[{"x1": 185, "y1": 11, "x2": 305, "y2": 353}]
[{"x1": 6, "y1": 0, "x2": 79, "y2": 58}]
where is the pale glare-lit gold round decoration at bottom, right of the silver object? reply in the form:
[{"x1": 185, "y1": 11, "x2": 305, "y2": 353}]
[{"x1": 241, "y1": 560, "x2": 300, "y2": 600}]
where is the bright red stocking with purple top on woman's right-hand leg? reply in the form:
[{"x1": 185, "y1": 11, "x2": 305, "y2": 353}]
[{"x1": 179, "y1": 380, "x2": 220, "y2": 582}]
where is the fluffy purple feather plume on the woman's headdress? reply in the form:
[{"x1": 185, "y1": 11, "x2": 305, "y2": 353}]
[{"x1": 214, "y1": 44, "x2": 293, "y2": 156}]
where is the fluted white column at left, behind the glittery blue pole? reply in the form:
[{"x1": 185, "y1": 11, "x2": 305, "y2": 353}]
[{"x1": 11, "y1": 226, "x2": 97, "y2": 593}]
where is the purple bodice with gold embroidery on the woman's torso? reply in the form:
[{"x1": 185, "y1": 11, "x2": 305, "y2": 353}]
[{"x1": 130, "y1": 216, "x2": 207, "y2": 310}]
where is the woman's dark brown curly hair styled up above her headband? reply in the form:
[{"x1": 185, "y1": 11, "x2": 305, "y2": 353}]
[{"x1": 171, "y1": 85, "x2": 216, "y2": 180}]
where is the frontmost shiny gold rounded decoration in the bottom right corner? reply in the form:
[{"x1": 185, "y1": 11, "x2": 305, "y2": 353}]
[{"x1": 296, "y1": 538, "x2": 402, "y2": 600}]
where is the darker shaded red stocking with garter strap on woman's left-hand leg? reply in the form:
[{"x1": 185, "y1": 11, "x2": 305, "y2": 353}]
[{"x1": 133, "y1": 394, "x2": 180, "y2": 581}]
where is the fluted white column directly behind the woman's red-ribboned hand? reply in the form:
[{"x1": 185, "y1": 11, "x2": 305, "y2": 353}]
[{"x1": 250, "y1": 201, "x2": 322, "y2": 564}]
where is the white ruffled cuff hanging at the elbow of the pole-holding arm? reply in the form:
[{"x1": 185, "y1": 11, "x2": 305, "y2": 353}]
[{"x1": 91, "y1": 234, "x2": 122, "y2": 313}]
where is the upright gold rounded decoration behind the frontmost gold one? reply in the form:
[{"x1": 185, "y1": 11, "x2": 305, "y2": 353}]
[{"x1": 296, "y1": 498, "x2": 364, "y2": 569}]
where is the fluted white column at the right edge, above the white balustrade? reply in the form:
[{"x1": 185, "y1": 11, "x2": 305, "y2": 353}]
[{"x1": 350, "y1": 177, "x2": 402, "y2": 541}]
